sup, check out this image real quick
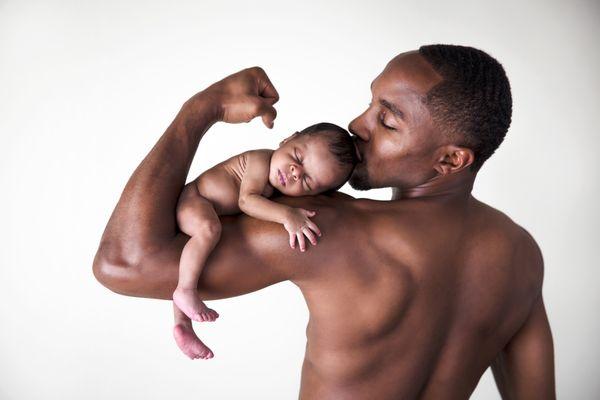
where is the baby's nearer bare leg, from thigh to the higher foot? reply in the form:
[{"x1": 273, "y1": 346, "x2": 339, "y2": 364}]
[{"x1": 173, "y1": 182, "x2": 221, "y2": 322}]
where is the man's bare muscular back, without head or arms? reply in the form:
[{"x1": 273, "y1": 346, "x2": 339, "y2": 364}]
[{"x1": 295, "y1": 197, "x2": 543, "y2": 399}]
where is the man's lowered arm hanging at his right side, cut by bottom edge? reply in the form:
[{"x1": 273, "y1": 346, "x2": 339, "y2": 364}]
[{"x1": 492, "y1": 295, "x2": 556, "y2": 400}]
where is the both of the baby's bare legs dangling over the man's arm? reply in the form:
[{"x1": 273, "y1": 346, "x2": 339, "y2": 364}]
[{"x1": 173, "y1": 182, "x2": 226, "y2": 359}]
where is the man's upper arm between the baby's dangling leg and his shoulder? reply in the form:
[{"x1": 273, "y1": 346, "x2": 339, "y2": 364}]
[{"x1": 198, "y1": 197, "x2": 340, "y2": 300}]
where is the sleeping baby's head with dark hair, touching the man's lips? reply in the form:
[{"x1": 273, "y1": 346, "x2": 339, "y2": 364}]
[{"x1": 269, "y1": 122, "x2": 358, "y2": 196}]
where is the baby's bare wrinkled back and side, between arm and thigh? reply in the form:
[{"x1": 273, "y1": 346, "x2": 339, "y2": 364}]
[{"x1": 193, "y1": 149, "x2": 273, "y2": 215}]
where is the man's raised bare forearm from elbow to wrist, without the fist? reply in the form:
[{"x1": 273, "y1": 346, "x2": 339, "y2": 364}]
[{"x1": 94, "y1": 93, "x2": 216, "y2": 271}]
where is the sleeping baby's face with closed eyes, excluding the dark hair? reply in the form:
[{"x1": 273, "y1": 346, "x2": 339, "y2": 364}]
[{"x1": 269, "y1": 134, "x2": 350, "y2": 196}]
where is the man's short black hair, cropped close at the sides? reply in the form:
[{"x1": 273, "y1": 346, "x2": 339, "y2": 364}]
[{"x1": 419, "y1": 44, "x2": 512, "y2": 171}]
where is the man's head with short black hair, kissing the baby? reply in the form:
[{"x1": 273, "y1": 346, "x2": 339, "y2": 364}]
[{"x1": 349, "y1": 45, "x2": 512, "y2": 190}]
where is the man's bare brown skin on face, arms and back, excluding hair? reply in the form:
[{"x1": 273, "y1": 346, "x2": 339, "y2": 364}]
[{"x1": 94, "y1": 52, "x2": 555, "y2": 400}]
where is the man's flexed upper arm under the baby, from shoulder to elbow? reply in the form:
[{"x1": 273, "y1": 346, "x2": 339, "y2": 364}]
[{"x1": 119, "y1": 197, "x2": 343, "y2": 300}]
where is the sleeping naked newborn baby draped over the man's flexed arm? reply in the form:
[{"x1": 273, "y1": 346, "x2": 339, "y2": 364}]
[{"x1": 173, "y1": 122, "x2": 357, "y2": 359}]
